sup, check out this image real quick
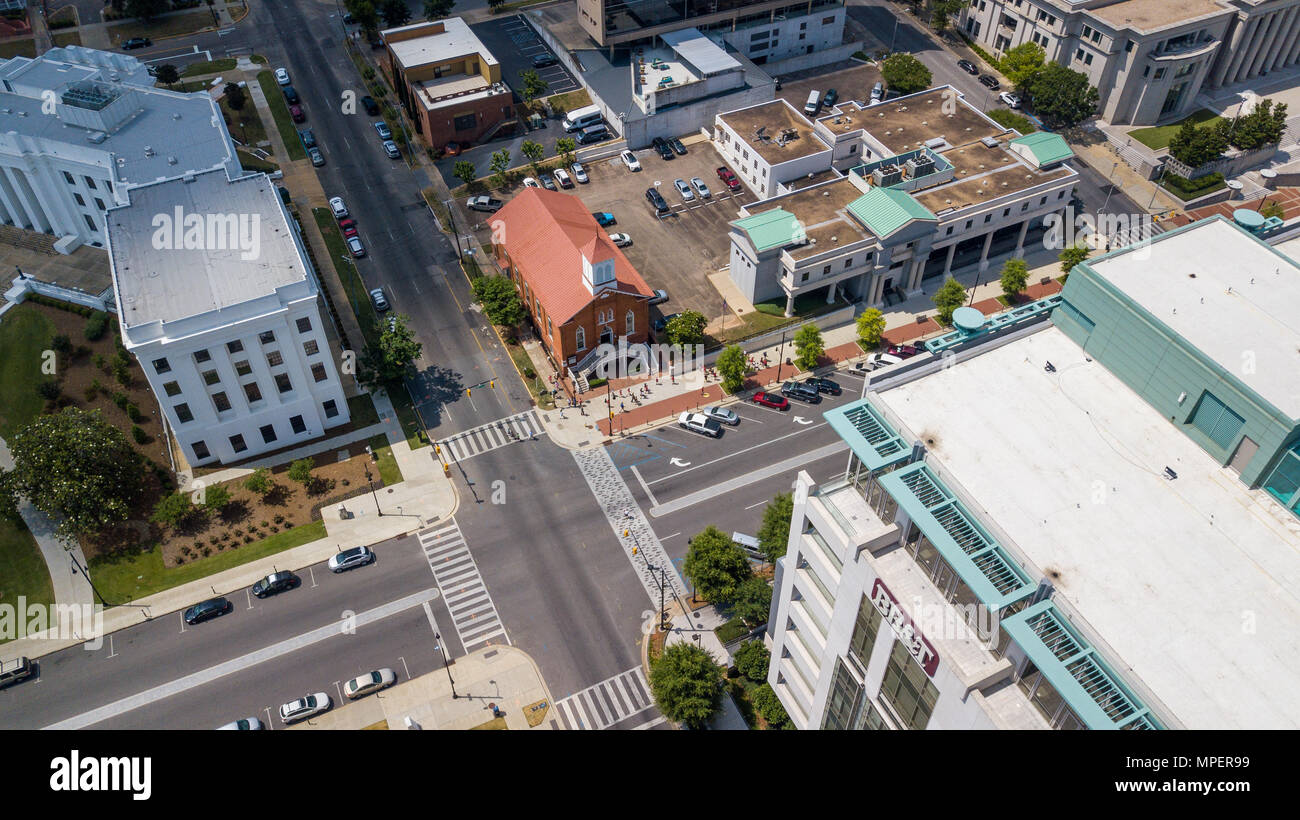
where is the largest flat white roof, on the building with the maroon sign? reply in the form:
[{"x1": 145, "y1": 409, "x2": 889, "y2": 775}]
[{"x1": 878, "y1": 327, "x2": 1300, "y2": 729}]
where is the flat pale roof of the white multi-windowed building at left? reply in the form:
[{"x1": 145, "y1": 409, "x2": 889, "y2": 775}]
[{"x1": 108, "y1": 172, "x2": 307, "y2": 327}]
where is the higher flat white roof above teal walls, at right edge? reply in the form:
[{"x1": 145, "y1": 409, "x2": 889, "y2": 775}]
[{"x1": 1089, "y1": 218, "x2": 1300, "y2": 418}]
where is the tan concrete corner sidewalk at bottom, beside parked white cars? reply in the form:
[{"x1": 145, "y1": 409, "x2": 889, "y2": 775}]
[{"x1": 302, "y1": 647, "x2": 556, "y2": 730}]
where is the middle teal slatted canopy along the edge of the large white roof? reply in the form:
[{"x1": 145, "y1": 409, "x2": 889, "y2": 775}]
[{"x1": 873, "y1": 462, "x2": 1037, "y2": 612}]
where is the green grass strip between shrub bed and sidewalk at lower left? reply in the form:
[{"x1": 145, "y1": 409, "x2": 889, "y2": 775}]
[{"x1": 90, "y1": 521, "x2": 325, "y2": 603}]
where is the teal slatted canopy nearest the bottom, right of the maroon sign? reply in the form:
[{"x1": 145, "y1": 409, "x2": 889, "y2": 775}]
[{"x1": 1001, "y1": 600, "x2": 1164, "y2": 729}]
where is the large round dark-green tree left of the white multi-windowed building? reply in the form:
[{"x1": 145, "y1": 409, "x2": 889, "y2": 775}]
[{"x1": 0, "y1": 407, "x2": 144, "y2": 539}]
